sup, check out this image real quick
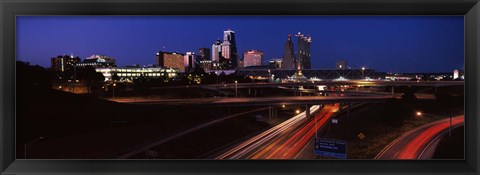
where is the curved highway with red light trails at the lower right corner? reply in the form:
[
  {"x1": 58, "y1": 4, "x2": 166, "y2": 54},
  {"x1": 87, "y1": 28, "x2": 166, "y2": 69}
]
[{"x1": 374, "y1": 115, "x2": 465, "y2": 159}]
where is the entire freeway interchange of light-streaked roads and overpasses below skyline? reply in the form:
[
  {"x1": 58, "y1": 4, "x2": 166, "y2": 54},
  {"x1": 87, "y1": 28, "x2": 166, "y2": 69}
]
[{"x1": 110, "y1": 81, "x2": 464, "y2": 159}]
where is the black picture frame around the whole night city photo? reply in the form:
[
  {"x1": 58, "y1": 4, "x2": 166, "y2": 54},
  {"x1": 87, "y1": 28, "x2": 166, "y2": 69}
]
[{"x1": 0, "y1": 0, "x2": 480, "y2": 175}]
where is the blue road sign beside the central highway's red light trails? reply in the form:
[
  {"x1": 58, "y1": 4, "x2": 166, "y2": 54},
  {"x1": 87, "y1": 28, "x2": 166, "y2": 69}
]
[{"x1": 314, "y1": 138, "x2": 347, "y2": 159}]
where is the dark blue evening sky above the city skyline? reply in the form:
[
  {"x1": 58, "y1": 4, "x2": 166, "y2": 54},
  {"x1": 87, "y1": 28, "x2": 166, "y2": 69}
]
[{"x1": 16, "y1": 16, "x2": 464, "y2": 73}]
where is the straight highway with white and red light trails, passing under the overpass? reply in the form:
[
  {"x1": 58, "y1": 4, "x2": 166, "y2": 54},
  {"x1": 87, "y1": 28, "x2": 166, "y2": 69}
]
[{"x1": 216, "y1": 103, "x2": 339, "y2": 159}]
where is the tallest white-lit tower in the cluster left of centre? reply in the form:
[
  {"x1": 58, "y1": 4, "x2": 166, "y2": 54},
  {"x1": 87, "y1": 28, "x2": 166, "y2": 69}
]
[{"x1": 221, "y1": 29, "x2": 238, "y2": 68}]
